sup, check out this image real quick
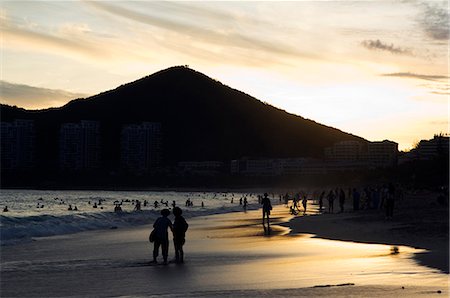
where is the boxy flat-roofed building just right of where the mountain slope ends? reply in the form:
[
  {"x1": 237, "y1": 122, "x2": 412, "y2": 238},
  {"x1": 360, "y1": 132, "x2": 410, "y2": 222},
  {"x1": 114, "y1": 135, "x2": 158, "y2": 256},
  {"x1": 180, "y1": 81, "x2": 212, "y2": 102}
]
[{"x1": 367, "y1": 140, "x2": 398, "y2": 168}]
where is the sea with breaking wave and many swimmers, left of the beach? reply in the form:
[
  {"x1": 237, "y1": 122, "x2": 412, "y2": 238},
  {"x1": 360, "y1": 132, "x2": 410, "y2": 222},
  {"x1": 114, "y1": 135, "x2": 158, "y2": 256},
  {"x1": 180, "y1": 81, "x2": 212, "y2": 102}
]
[{"x1": 0, "y1": 189, "x2": 259, "y2": 245}]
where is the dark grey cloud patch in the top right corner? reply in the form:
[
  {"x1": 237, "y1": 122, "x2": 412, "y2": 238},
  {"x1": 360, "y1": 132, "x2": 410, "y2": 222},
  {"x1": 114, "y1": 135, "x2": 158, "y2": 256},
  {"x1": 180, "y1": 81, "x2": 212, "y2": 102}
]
[{"x1": 418, "y1": 1, "x2": 450, "y2": 41}]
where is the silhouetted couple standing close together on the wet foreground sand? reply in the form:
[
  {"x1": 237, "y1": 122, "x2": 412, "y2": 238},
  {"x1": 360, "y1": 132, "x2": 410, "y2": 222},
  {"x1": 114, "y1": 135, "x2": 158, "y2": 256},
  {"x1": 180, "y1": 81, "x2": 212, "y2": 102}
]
[{"x1": 150, "y1": 207, "x2": 189, "y2": 264}]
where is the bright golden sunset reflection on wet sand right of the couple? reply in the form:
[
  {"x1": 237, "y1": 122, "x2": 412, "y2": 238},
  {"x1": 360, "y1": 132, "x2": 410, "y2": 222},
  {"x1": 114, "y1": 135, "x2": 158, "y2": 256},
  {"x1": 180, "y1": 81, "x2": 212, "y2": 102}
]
[{"x1": 185, "y1": 205, "x2": 448, "y2": 288}]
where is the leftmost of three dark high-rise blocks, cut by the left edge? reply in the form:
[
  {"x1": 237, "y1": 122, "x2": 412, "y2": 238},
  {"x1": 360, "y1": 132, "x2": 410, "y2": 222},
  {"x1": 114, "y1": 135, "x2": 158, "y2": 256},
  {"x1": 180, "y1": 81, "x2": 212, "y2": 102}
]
[{"x1": 0, "y1": 119, "x2": 35, "y2": 171}]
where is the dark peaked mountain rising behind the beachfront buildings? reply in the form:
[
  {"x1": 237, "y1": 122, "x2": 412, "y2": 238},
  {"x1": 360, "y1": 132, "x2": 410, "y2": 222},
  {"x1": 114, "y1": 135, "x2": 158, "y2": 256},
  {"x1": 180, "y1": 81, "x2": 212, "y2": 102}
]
[{"x1": 1, "y1": 66, "x2": 367, "y2": 170}]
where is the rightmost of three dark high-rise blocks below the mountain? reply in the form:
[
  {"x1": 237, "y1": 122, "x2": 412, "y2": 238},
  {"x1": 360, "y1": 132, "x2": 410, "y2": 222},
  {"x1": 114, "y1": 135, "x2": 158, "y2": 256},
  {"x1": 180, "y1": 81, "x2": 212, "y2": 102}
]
[{"x1": 121, "y1": 122, "x2": 162, "y2": 175}]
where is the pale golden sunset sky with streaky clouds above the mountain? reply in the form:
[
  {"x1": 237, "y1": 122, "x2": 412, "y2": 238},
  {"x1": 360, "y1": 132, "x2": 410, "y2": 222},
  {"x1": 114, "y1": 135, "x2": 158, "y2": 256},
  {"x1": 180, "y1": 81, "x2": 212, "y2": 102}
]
[{"x1": 0, "y1": 0, "x2": 450, "y2": 150}]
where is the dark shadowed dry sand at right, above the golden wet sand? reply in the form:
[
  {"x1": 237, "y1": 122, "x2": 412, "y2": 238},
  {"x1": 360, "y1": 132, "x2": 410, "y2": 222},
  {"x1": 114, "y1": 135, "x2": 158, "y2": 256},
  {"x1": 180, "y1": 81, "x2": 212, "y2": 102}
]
[{"x1": 284, "y1": 193, "x2": 449, "y2": 274}]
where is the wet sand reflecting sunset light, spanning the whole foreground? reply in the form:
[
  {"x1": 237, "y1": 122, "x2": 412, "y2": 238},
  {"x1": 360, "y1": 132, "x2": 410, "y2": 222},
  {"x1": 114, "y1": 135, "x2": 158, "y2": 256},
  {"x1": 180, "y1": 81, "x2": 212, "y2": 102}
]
[{"x1": 1, "y1": 199, "x2": 448, "y2": 297}]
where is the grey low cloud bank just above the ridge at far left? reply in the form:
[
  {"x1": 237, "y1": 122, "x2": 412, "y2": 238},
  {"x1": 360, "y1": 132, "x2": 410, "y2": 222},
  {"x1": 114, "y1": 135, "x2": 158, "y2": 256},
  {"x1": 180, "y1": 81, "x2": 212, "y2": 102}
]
[{"x1": 0, "y1": 80, "x2": 87, "y2": 109}]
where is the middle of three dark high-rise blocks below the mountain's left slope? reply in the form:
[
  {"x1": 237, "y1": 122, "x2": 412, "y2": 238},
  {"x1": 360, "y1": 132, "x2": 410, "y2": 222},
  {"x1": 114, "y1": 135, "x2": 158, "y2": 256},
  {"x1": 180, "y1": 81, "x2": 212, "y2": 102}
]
[{"x1": 59, "y1": 120, "x2": 100, "y2": 171}]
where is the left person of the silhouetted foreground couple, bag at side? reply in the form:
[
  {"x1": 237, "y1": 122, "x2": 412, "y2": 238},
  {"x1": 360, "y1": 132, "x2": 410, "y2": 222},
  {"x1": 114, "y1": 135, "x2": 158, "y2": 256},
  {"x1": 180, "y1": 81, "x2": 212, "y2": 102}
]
[{"x1": 153, "y1": 209, "x2": 173, "y2": 265}]
